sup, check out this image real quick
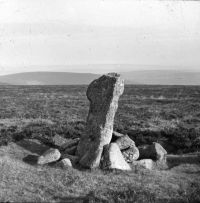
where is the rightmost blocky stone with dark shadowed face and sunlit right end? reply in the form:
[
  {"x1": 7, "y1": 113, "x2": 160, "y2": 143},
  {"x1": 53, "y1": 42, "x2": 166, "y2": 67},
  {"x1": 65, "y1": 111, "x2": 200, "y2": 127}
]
[{"x1": 138, "y1": 142, "x2": 167, "y2": 161}]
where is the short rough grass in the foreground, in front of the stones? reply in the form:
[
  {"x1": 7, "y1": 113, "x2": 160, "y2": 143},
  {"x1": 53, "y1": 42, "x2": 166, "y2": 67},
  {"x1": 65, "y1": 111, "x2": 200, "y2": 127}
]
[{"x1": 0, "y1": 140, "x2": 200, "y2": 202}]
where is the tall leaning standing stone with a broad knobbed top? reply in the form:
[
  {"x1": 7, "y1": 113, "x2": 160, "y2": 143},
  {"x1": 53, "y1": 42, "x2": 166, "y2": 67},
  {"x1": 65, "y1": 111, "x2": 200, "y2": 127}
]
[{"x1": 76, "y1": 73, "x2": 124, "y2": 168}]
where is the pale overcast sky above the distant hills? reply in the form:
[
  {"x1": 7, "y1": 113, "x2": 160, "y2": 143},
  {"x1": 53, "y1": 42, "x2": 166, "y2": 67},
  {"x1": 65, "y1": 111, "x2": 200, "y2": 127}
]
[{"x1": 0, "y1": 0, "x2": 200, "y2": 75}]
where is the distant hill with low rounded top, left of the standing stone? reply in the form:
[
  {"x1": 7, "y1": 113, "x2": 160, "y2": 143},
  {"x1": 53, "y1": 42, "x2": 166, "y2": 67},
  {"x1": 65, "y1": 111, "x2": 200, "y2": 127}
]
[{"x1": 0, "y1": 72, "x2": 99, "y2": 85}]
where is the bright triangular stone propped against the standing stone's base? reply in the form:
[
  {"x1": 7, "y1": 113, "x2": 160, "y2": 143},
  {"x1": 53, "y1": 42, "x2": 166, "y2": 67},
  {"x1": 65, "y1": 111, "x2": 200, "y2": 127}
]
[{"x1": 101, "y1": 143, "x2": 131, "y2": 170}]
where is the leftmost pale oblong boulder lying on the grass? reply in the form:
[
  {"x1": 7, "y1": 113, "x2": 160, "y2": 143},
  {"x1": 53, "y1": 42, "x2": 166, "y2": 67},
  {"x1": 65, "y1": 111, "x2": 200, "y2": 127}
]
[{"x1": 37, "y1": 148, "x2": 61, "y2": 165}]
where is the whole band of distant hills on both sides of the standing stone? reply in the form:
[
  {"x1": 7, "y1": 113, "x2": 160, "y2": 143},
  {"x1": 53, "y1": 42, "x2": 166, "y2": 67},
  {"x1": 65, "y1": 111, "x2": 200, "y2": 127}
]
[{"x1": 0, "y1": 70, "x2": 200, "y2": 85}]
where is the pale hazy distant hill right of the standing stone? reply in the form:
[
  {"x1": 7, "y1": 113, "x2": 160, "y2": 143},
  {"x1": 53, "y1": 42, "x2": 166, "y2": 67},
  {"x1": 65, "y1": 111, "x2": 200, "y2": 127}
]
[{"x1": 121, "y1": 70, "x2": 200, "y2": 85}]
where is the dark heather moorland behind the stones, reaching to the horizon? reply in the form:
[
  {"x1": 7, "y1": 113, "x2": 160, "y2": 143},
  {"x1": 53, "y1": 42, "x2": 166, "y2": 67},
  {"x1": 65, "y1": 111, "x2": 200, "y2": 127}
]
[{"x1": 0, "y1": 85, "x2": 200, "y2": 153}]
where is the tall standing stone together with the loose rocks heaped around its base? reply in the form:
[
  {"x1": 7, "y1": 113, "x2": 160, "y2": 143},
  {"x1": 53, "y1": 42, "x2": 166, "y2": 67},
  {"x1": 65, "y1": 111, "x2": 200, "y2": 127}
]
[{"x1": 38, "y1": 73, "x2": 167, "y2": 170}]
